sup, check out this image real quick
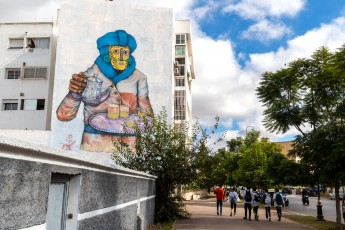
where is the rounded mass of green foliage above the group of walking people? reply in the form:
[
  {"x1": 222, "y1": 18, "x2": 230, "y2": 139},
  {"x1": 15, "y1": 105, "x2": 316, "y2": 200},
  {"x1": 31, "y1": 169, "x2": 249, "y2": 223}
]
[{"x1": 213, "y1": 130, "x2": 300, "y2": 188}]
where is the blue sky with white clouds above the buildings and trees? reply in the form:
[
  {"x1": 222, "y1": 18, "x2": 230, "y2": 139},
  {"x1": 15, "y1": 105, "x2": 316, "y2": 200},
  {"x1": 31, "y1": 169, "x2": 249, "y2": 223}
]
[{"x1": 0, "y1": 0, "x2": 345, "y2": 150}]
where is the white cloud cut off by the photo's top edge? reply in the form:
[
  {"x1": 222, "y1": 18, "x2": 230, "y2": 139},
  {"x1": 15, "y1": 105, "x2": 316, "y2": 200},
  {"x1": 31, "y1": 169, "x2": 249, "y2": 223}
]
[{"x1": 224, "y1": 0, "x2": 306, "y2": 21}]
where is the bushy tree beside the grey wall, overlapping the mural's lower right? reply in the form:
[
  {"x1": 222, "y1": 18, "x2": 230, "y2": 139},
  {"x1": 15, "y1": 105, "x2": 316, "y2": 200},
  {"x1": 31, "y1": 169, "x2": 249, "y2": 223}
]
[{"x1": 113, "y1": 109, "x2": 219, "y2": 222}]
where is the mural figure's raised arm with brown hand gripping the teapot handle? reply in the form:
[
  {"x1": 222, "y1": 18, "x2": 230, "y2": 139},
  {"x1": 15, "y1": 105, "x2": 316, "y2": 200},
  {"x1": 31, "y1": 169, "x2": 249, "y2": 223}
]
[{"x1": 56, "y1": 72, "x2": 87, "y2": 121}]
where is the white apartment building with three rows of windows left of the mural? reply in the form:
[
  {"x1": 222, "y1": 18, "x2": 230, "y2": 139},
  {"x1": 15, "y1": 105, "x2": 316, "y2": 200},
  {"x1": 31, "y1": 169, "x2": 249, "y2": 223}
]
[{"x1": 0, "y1": 22, "x2": 56, "y2": 130}]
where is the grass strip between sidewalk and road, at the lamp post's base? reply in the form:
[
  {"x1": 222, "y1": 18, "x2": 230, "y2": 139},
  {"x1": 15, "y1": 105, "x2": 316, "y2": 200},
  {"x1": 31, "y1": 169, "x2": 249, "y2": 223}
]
[{"x1": 283, "y1": 214, "x2": 345, "y2": 230}]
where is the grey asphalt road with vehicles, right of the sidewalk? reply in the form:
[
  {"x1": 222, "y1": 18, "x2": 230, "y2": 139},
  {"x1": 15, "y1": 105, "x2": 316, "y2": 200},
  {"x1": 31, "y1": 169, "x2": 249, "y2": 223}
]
[{"x1": 283, "y1": 195, "x2": 344, "y2": 222}]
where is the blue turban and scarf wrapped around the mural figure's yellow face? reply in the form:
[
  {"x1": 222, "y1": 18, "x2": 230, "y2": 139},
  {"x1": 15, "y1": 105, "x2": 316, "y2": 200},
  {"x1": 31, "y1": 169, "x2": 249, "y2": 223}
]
[{"x1": 95, "y1": 30, "x2": 137, "y2": 84}]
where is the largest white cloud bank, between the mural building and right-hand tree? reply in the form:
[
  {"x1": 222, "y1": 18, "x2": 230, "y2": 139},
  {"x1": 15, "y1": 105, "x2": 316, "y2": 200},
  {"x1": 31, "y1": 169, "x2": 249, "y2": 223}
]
[{"x1": 192, "y1": 15, "x2": 345, "y2": 143}]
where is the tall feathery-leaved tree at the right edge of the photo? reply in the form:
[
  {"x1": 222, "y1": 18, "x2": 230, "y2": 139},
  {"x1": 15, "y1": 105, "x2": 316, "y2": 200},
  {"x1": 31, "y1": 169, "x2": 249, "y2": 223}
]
[{"x1": 257, "y1": 46, "x2": 345, "y2": 229}]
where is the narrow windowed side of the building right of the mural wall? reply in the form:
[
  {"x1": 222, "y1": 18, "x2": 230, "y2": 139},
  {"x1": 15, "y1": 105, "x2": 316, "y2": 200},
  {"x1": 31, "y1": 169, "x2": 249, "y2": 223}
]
[{"x1": 173, "y1": 20, "x2": 195, "y2": 131}]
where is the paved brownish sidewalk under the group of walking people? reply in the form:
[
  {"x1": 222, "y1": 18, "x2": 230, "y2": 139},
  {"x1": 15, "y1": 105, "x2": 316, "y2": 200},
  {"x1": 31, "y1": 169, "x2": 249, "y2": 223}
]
[{"x1": 173, "y1": 198, "x2": 311, "y2": 230}]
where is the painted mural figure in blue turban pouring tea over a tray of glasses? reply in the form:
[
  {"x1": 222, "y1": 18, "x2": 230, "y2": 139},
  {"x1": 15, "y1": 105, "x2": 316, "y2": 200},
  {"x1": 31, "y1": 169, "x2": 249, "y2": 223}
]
[{"x1": 56, "y1": 30, "x2": 153, "y2": 152}]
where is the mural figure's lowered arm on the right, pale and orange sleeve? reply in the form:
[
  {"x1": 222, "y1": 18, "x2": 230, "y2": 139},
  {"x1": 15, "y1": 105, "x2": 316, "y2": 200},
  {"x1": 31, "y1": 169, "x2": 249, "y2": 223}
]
[{"x1": 138, "y1": 75, "x2": 153, "y2": 114}]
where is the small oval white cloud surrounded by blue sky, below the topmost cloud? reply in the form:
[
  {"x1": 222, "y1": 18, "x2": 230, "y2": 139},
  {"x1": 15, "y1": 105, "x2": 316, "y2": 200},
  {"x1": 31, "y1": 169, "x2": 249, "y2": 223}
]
[{"x1": 242, "y1": 20, "x2": 292, "y2": 42}]
